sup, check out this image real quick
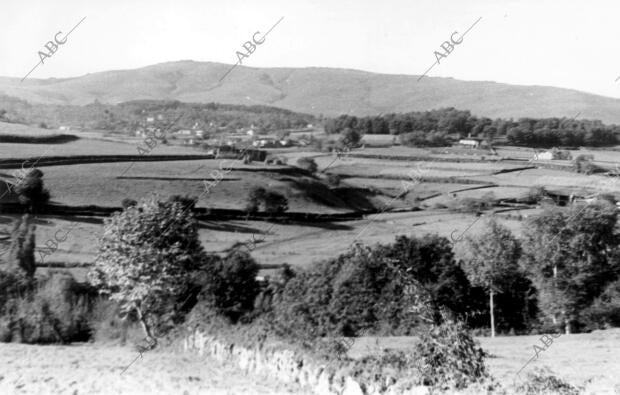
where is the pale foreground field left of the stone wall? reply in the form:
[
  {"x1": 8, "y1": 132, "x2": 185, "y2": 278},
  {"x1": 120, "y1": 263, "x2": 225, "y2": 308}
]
[{"x1": 0, "y1": 343, "x2": 304, "y2": 395}]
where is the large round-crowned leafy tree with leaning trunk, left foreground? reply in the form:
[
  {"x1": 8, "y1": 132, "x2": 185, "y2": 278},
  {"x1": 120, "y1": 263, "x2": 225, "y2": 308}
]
[{"x1": 88, "y1": 198, "x2": 206, "y2": 346}]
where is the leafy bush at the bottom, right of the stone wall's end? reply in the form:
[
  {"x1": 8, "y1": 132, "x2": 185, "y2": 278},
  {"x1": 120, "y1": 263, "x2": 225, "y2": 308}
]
[{"x1": 415, "y1": 320, "x2": 489, "y2": 390}]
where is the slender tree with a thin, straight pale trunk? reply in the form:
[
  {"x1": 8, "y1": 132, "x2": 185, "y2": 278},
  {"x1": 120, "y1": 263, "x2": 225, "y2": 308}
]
[{"x1": 465, "y1": 218, "x2": 521, "y2": 337}]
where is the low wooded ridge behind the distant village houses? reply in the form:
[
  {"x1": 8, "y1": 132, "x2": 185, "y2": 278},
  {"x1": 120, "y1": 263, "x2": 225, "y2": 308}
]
[{"x1": 0, "y1": 96, "x2": 318, "y2": 133}]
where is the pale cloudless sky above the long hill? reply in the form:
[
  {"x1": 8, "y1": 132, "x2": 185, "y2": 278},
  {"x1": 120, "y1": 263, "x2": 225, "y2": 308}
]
[{"x1": 0, "y1": 0, "x2": 620, "y2": 98}]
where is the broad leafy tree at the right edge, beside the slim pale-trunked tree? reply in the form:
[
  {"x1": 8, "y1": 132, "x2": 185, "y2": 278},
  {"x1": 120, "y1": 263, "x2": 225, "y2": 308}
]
[{"x1": 523, "y1": 201, "x2": 620, "y2": 333}]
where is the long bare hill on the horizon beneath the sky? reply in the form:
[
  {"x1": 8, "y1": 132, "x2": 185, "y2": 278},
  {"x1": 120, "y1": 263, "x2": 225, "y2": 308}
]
[{"x1": 0, "y1": 61, "x2": 620, "y2": 123}]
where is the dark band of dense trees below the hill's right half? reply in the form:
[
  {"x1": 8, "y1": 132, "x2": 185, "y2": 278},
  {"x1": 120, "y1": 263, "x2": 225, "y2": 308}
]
[{"x1": 325, "y1": 108, "x2": 620, "y2": 147}]
